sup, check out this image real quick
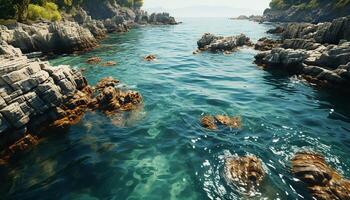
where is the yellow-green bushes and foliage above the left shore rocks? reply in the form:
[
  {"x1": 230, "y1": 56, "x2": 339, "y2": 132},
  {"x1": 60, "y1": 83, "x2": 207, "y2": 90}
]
[{"x1": 0, "y1": 0, "x2": 143, "y2": 22}]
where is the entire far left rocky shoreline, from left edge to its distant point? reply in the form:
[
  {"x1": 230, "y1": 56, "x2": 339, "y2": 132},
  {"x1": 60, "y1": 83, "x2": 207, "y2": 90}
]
[{"x1": 0, "y1": 1, "x2": 178, "y2": 54}]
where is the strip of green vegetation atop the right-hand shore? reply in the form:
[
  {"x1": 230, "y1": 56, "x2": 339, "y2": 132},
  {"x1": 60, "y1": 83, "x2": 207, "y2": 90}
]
[{"x1": 270, "y1": 0, "x2": 350, "y2": 10}]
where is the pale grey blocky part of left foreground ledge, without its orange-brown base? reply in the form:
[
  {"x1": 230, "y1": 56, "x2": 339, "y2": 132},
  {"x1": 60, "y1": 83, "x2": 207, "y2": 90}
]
[{"x1": 0, "y1": 43, "x2": 87, "y2": 148}]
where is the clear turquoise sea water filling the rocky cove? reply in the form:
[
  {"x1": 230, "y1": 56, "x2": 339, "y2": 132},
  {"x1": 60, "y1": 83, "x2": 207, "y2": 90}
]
[{"x1": 0, "y1": 19, "x2": 350, "y2": 199}]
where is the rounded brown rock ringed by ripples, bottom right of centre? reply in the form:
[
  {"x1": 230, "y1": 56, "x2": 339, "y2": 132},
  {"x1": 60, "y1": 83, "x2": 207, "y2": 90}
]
[{"x1": 225, "y1": 156, "x2": 265, "y2": 192}]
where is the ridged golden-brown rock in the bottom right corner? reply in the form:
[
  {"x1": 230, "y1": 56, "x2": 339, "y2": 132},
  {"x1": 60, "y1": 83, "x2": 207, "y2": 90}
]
[{"x1": 292, "y1": 152, "x2": 350, "y2": 200}]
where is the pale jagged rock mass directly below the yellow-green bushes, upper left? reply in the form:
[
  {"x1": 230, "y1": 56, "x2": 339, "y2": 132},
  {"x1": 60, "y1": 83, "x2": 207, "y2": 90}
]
[{"x1": 0, "y1": 21, "x2": 97, "y2": 53}]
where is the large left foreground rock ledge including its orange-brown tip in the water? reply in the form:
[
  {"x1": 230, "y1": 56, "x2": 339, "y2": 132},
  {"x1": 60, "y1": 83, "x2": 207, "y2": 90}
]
[{"x1": 0, "y1": 42, "x2": 142, "y2": 156}]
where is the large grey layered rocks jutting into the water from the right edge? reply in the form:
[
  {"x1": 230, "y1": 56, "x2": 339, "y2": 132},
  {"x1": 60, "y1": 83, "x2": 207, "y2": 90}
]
[{"x1": 255, "y1": 17, "x2": 350, "y2": 89}]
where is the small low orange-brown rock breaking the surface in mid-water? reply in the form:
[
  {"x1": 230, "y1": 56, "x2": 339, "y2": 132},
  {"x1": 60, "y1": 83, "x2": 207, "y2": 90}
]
[{"x1": 200, "y1": 115, "x2": 242, "y2": 130}]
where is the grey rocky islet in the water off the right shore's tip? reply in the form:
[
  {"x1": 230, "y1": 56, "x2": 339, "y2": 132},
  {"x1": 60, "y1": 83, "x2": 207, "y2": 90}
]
[{"x1": 197, "y1": 33, "x2": 252, "y2": 52}]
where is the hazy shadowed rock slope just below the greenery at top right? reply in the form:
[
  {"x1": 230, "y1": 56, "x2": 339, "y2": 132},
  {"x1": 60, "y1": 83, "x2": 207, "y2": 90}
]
[{"x1": 264, "y1": 0, "x2": 350, "y2": 23}]
